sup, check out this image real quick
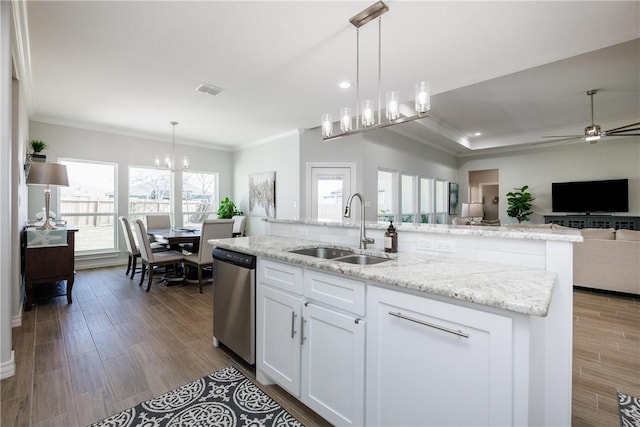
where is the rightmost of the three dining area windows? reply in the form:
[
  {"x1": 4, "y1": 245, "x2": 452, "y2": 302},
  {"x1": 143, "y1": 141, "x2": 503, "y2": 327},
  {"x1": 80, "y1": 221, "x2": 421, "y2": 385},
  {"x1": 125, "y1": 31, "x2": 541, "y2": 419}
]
[{"x1": 182, "y1": 172, "x2": 218, "y2": 225}]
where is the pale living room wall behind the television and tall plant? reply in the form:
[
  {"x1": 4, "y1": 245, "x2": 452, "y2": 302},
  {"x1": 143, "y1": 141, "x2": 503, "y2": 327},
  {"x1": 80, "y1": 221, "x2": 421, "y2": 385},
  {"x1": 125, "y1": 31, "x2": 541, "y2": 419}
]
[{"x1": 458, "y1": 142, "x2": 640, "y2": 223}]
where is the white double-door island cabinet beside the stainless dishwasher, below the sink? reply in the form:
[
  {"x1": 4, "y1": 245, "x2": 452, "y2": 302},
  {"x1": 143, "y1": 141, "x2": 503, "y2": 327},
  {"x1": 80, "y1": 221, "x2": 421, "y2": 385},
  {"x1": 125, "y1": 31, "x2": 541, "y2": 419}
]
[{"x1": 256, "y1": 259, "x2": 366, "y2": 426}]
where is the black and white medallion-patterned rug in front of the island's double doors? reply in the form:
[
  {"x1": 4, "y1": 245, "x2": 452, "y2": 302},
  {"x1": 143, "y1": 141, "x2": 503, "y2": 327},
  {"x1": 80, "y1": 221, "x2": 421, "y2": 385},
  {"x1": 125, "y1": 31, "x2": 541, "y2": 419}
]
[{"x1": 90, "y1": 366, "x2": 303, "y2": 427}]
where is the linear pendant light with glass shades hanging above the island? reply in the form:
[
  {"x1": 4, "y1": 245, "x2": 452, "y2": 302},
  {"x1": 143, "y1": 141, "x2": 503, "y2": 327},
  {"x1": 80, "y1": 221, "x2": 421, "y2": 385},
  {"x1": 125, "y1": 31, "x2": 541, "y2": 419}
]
[{"x1": 321, "y1": 1, "x2": 431, "y2": 141}]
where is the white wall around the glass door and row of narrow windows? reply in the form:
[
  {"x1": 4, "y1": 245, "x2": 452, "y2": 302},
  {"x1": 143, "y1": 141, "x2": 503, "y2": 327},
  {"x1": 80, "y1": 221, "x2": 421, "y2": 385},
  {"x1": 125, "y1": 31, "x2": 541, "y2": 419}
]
[{"x1": 300, "y1": 125, "x2": 466, "y2": 222}]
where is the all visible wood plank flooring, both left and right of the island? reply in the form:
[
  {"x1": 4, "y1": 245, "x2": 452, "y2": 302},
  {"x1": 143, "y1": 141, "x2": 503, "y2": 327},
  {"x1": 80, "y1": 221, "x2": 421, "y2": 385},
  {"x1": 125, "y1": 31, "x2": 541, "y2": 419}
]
[{"x1": 0, "y1": 268, "x2": 640, "y2": 427}]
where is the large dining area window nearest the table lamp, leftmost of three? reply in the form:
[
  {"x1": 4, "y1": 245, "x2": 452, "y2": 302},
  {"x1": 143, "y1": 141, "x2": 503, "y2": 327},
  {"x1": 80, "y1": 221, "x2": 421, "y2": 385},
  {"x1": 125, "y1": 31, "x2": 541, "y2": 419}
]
[{"x1": 59, "y1": 160, "x2": 117, "y2": 253}]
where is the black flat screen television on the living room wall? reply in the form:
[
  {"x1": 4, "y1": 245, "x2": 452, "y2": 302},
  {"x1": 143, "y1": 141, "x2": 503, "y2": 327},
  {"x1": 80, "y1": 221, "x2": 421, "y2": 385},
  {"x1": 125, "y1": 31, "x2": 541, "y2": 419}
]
[{"x1": 551, "y1": 179, "x2": 629, "y2": 213}]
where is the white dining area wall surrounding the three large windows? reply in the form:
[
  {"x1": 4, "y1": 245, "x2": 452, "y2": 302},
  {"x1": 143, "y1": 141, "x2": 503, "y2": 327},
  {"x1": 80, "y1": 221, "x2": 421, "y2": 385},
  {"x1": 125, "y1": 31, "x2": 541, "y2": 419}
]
[{"x1": 28, "y1": 120, "x2": 233, "y2": 268}]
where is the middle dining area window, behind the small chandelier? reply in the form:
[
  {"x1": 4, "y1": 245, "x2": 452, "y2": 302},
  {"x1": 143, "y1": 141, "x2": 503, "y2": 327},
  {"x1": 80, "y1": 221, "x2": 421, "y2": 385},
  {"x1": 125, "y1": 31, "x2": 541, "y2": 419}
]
[{"x1": 129, "y1": 167, "x2": 173, "y2": 226}]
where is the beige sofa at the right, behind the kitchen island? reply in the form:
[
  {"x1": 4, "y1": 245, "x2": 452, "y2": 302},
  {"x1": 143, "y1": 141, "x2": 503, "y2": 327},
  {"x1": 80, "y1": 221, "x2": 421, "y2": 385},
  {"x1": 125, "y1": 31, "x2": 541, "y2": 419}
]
[{"x1": 573, "y1": 228, "x2": 640, "y2": 295}]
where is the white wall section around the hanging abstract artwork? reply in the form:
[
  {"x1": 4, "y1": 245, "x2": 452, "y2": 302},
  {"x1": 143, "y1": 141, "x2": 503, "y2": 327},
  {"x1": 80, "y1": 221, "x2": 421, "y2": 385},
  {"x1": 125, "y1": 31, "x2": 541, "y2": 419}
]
[{"x1": 234, "y1": 131, "x2": 300, "y2": 236}]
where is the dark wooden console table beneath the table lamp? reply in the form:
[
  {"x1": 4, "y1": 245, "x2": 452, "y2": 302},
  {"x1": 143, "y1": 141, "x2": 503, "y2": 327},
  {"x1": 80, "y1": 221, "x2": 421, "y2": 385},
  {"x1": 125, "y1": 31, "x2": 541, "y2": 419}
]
[{"x1": 21, "y1": 228, "x2": 78, "y2": 310}]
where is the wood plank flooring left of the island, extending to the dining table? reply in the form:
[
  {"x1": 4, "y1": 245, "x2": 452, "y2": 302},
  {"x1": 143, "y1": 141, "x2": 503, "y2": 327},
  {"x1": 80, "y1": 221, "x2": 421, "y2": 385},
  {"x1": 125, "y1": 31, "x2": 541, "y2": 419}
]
[{"x1": 0, "y1": 267, "x2": 329, "y2": 427}]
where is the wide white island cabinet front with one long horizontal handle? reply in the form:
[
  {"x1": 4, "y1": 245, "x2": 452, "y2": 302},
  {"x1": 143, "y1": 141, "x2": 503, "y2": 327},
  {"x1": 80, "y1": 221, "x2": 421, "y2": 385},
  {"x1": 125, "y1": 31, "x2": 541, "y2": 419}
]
[{"x1": 366, "y1": 286, "x2": 514, "y2": 426}]
